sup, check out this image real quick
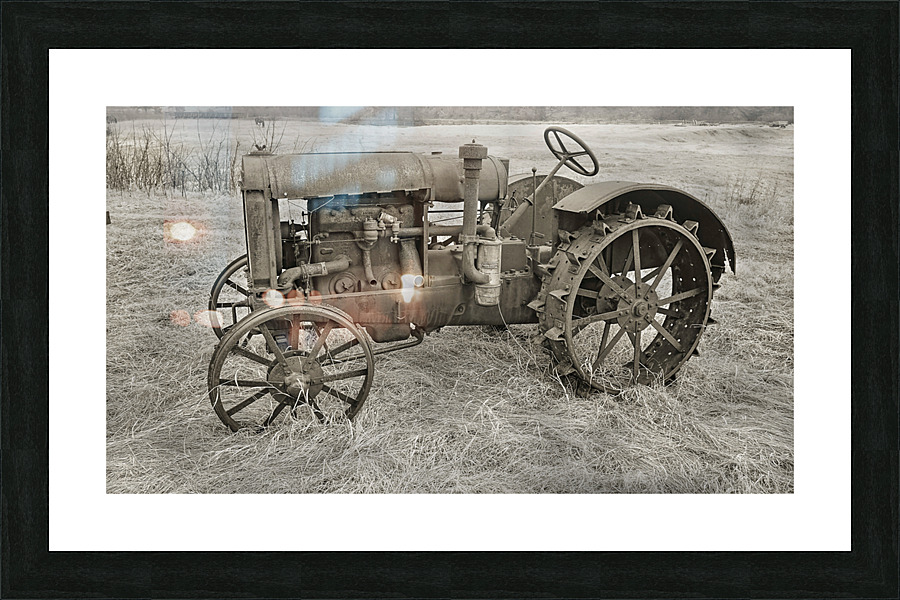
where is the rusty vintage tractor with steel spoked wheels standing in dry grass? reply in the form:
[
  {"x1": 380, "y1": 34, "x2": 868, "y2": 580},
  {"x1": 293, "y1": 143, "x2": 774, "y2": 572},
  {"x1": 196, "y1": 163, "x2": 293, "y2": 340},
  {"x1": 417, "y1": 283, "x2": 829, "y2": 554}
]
[{"x1": 208, "y1": 127, "x2": 735, "y2": 431}]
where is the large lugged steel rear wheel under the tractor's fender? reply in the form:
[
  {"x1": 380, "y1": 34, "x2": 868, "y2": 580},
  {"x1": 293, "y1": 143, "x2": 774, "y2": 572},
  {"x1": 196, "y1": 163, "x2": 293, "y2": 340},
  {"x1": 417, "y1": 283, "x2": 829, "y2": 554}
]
[{"x1": 540, "y1": 211, "x2": 713, "y2": 393}]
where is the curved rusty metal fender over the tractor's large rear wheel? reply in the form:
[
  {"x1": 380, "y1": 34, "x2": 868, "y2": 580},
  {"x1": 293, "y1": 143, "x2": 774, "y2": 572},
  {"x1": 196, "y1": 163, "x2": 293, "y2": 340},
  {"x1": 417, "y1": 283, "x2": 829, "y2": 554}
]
[{"x1": 553, "y1": 181, "x2": 735, "y2": 279}]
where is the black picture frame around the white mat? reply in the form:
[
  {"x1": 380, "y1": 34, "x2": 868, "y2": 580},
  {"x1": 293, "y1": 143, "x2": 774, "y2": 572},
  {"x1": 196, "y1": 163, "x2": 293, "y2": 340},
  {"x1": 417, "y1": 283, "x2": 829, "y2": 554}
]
[{"x1": 0, "y1": 1, "x2": 900, "y2": 598}]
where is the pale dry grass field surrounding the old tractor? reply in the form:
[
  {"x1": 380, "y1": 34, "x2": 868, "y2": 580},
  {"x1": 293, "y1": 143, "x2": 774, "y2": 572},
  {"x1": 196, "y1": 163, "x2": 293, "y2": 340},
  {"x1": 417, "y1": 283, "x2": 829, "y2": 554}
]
[{"x1": 106, "y1": 120, "x2": 794, "y2": 494}]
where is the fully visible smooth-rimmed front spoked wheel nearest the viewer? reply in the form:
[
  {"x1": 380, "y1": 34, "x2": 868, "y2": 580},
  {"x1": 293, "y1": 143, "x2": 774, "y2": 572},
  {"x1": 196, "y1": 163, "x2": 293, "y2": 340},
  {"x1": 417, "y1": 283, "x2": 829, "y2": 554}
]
[{"x1": 207, "y1": 304, "x2": 375, "y2": 431}]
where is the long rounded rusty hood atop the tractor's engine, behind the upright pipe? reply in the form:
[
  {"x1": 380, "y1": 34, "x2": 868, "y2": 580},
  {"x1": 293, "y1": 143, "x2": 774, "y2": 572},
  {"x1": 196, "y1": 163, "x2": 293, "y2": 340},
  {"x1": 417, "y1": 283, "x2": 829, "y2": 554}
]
[{"x1": 243, "y1": 152, "x2": 507, "y2": 202}]
